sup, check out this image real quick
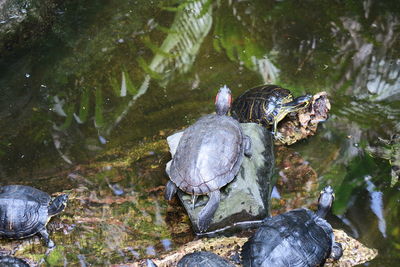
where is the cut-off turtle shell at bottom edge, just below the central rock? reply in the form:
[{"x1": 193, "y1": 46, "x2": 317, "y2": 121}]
[{"x1": 177, "y1": 251, "x2": 234, "y2": 267}]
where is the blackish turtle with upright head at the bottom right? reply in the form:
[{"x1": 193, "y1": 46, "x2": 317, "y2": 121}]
[{"x1": 241, "y1": 186, "x2": 343, "y2": 267}]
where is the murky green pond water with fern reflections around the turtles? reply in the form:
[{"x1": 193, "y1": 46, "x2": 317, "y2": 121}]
[{"x1": 0, "y1": 0, "x2": 400, "y2": 266}]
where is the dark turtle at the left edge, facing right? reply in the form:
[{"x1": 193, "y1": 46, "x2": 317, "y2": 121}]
[{"x1": 0, "y1": 185, "x2": 68, "y2": 248}]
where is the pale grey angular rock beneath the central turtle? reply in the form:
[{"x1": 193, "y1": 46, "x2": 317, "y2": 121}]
[{"x1": 166, "y1": 123, "x2": 275, "y2": 235}]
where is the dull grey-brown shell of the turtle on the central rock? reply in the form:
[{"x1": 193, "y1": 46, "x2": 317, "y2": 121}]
[{"x1": 170, "y1": 115, "x2": 244, "y2": 195}]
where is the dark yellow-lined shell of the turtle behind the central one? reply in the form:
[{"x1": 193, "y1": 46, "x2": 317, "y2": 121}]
[{"x1": 231, "y1": 85, "x2": 293, "y2": 126}]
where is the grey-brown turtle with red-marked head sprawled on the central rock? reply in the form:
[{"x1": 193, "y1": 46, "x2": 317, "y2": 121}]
[{"x1": 165, "y1": 86, "x2": 251, "y2": 232}]
